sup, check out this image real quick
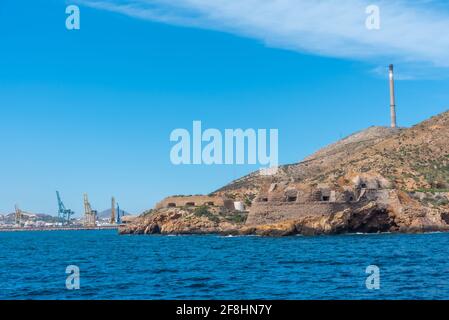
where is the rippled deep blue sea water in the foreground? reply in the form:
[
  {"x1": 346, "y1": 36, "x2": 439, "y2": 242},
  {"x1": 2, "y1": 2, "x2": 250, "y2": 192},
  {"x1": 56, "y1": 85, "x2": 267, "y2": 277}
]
[{"x1": 0, "y1": 230, "x2": 449, "y2": 299}]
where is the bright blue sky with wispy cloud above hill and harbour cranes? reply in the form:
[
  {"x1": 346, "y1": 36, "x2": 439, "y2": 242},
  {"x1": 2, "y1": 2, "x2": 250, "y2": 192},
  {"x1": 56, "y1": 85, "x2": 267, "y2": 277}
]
[{"x1": 0, "y1": 0, "x2": 449, "y2": 216}]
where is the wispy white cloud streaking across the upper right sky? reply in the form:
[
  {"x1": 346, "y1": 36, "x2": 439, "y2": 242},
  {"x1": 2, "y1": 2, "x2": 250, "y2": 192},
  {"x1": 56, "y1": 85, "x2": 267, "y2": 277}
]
[{"x1": 78, "y1": 0, "x2": 449, "y2": 78}]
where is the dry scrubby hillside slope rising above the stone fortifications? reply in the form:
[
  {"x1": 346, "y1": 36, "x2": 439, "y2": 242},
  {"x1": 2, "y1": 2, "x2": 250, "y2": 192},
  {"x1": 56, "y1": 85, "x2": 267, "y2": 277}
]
[{"x1": 216, "y1": 111, "x2": 449, "y2": 198}]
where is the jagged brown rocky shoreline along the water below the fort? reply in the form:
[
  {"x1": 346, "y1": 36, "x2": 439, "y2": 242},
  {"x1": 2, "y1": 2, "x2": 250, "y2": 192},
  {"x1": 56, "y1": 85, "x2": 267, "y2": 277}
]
[{"x1": 119, "y1": 194, "x2": 449, "y2": 237}]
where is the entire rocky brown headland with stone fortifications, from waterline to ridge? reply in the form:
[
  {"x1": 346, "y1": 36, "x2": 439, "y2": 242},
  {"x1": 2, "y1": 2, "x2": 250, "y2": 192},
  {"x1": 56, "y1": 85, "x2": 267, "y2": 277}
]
[{"x1": 121, "y1": 112, "x2": 449, "y2": 236}]
